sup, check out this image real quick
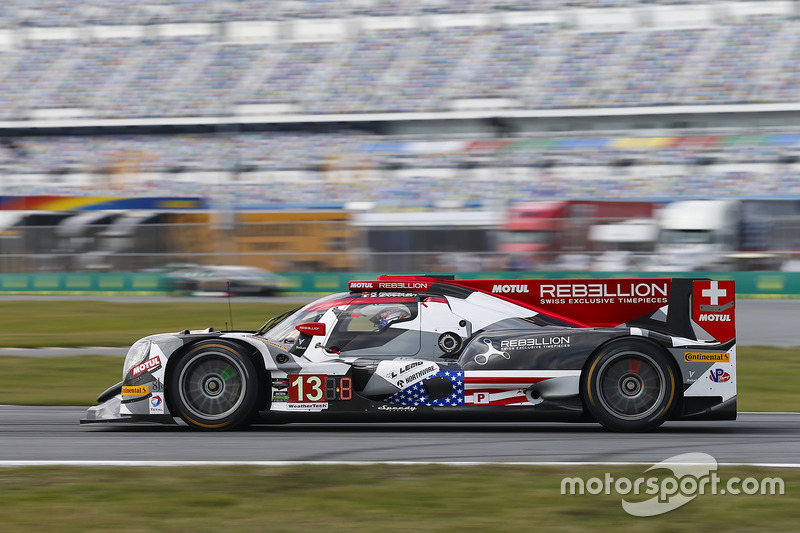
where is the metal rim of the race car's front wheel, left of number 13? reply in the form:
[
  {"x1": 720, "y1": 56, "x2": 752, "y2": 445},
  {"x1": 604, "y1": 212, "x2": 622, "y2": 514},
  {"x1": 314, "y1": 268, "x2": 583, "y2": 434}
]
[{"x1": 179, "y1": 352, "x2": 247, "y2": 420}]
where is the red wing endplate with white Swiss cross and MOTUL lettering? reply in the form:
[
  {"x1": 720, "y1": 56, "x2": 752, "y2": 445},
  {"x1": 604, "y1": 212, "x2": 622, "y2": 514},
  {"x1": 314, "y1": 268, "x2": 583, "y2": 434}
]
[{"x1": 692, "y1": 280, "x2": 736, "y2": 342}]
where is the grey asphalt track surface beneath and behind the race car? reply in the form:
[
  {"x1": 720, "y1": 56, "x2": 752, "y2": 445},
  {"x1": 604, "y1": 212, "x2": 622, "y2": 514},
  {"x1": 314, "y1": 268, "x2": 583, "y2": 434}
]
[{"x1": 0, "y1": 300, "x2": 800, "y2": 467}]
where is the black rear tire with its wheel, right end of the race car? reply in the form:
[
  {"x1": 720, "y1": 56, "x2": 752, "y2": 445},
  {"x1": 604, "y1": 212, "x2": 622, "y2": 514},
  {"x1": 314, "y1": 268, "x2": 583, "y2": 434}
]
[{"x1": 580, "y1": 339, "x2": 680, "y2": 432}]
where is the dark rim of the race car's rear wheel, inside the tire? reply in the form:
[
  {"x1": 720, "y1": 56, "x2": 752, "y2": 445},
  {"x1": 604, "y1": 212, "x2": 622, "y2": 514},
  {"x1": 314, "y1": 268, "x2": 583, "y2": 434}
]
[{"x1": 597, "y1": 352, "x2": 667, "y2": 420}]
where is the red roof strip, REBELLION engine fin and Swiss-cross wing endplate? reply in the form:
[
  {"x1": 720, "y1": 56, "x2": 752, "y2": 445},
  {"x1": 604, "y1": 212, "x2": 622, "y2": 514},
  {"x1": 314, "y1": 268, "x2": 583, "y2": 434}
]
[{"x1": 350, "y1": 276, "x2": 736, "y2": 343}]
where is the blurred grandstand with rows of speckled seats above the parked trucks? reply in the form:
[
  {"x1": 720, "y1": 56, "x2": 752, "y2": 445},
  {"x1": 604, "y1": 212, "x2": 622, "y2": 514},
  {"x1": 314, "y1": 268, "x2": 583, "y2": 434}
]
[{"x1": 0, "y1": 0, "x2": 800, "y2": 210}]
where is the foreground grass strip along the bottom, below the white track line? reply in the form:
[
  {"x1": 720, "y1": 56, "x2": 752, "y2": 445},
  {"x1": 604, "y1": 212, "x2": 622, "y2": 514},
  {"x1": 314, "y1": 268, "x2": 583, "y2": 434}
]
[{"x1": 0, "y1": 465, "x2": 800, "y2": 533}]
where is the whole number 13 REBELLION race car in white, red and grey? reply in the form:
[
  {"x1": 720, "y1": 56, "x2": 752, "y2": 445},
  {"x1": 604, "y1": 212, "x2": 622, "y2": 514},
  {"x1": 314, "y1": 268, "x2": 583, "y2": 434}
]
[{"x1": 82, "y1": 276, "x2": 736, "y2": 431}]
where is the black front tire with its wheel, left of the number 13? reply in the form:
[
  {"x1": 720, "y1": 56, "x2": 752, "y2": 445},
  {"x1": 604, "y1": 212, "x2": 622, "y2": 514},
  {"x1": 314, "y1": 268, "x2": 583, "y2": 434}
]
[{"x1": 167, "y1": 339, "x2": 260, "y2": 431}]
